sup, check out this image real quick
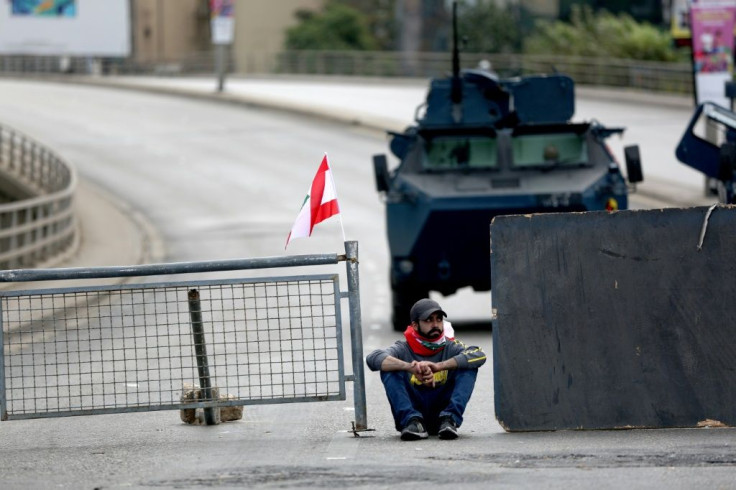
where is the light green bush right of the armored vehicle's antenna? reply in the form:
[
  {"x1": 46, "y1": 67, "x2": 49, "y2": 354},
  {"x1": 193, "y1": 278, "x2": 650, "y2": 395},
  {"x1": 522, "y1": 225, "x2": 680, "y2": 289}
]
[{"x1": 524, "y1": 5, "x2": 680, "y2": 61}]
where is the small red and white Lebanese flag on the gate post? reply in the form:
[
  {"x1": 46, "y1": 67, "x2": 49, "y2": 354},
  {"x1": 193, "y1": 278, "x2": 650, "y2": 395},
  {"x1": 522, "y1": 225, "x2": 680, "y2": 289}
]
[{"x1": 284, "y1": 154, "x2": 340, "y2": 249}]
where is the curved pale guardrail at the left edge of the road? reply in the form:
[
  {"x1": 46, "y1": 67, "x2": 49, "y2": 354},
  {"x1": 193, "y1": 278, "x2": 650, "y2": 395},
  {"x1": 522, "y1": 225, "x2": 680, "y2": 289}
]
[{"x1": 0, "y1": 125, "x2": 78, "y2": 269}]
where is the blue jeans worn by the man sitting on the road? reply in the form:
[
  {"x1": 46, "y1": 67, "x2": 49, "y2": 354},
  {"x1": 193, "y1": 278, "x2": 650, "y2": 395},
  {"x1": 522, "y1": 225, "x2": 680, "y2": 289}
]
[{"x1": 381, "y1": 369, "x2": 478, "y2": 434}]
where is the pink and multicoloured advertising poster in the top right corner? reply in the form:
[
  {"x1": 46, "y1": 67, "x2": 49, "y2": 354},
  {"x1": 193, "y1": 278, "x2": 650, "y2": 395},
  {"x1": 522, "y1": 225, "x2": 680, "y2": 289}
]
[{"x1": 690, "y1": 3, "x2": 736, "y2": 107}]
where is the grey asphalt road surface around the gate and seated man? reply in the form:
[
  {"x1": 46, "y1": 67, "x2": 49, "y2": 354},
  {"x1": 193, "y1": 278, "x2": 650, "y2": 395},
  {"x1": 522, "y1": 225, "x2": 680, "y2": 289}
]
[{"x1": 0, "y1": 81, "x2": 736, "y2": 489}]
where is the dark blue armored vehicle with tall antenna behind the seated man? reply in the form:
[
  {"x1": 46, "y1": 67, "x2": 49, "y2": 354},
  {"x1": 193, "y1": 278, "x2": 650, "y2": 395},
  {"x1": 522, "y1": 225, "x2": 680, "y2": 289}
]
[{"x1": 373, "y1": 1, "x2": 643, "y2": 330}]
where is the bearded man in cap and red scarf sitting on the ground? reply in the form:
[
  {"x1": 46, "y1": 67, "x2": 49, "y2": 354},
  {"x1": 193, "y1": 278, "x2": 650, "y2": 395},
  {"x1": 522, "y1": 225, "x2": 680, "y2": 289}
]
[{"x1": 366, "y1": 299, "x2": 486, "y2": 441}]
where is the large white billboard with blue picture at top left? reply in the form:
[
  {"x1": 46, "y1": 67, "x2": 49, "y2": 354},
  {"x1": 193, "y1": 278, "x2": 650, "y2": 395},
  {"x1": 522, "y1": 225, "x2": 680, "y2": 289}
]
[{"x1": 0, "y1": 0, "x2": 131, "y2": 57}]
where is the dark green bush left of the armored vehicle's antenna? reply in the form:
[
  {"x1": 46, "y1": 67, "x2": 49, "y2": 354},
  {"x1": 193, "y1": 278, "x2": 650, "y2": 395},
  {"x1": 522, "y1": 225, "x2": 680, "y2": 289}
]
[{"x1": 286, "y1": 0, "x2": 376, "y2": 51}]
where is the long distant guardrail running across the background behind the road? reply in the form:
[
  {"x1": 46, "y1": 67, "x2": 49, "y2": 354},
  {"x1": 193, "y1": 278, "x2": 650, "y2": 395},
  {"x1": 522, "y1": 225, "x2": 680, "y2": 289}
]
[{"x1": 0, "y1": 50, "x2": 693, "y2": 94}]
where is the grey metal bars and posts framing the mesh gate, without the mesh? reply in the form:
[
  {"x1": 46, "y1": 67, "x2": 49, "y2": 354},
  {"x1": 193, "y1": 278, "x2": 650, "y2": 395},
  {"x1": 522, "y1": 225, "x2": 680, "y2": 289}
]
[{"x1": 0, "y1": 241, "x2": 368, "y2": 432}]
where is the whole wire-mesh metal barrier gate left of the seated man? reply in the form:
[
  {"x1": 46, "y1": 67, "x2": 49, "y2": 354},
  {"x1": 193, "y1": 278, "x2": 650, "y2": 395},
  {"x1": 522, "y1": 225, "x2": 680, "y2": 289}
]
[{"x1": 0, "y1": 242, "x2": 367, "y2": 430}]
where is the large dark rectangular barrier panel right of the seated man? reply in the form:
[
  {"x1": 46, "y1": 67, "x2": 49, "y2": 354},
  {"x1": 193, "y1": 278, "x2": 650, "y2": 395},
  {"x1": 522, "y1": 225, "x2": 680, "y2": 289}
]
[{"x1": 491, "y1": 206, "x2": 736, "y2": 431}]
